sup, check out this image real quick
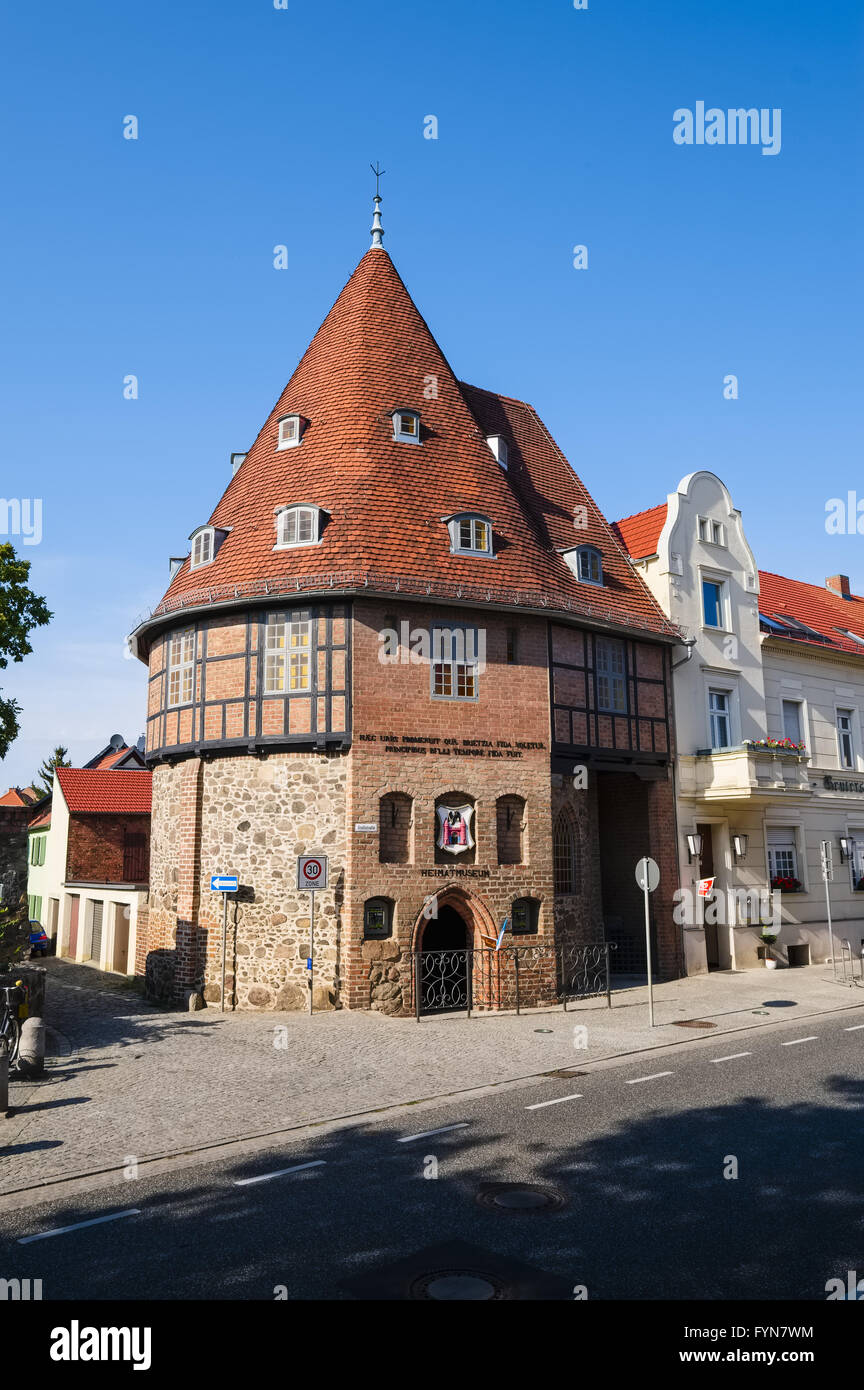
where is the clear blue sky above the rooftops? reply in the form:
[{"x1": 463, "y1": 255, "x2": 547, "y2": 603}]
[{"x1": 0, "y1": 0, "x2": 864, "y2": 785}]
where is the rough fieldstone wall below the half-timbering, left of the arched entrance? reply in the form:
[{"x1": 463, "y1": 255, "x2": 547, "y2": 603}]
[{"x1": 138, "y1": 752, "x2": 347, "y2": 1009}]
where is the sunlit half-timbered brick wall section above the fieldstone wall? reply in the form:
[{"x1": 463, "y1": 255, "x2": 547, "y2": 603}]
[{"x1": 147, "y1": 603, "x2": 351, "y2": 759}]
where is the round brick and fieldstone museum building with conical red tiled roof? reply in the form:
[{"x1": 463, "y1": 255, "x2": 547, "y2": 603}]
[{"x1": 132, "y1": 201, "x2": 681, "y2": 1013}]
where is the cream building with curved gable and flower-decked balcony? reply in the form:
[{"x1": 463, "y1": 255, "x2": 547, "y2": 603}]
[{"x1": 614, "y1": 471, "x2": 864, "y2": 973}]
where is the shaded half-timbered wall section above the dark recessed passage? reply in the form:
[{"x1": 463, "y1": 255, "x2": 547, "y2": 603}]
[{"x1": 549, "y1": 623, "x2": 671, "y2": 760}]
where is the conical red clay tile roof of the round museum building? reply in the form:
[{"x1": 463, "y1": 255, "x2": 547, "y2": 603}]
[{"x1": 140, "y1": 249, "x2": 675, "y2": 632}]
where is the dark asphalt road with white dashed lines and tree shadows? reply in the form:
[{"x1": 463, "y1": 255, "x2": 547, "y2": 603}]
[{"x1": 0, "y1": 1008, "x2": 864, "y2": 1301}]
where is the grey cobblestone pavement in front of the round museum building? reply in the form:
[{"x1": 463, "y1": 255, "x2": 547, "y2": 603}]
[{"x1": 0, "y1": 959, "x2": 864, "y2": 1193}]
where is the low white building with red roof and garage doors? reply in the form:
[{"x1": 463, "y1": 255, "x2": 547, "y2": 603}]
[{"x1": 28, "y1": 767, "x2": 151, "y2": 974}]
